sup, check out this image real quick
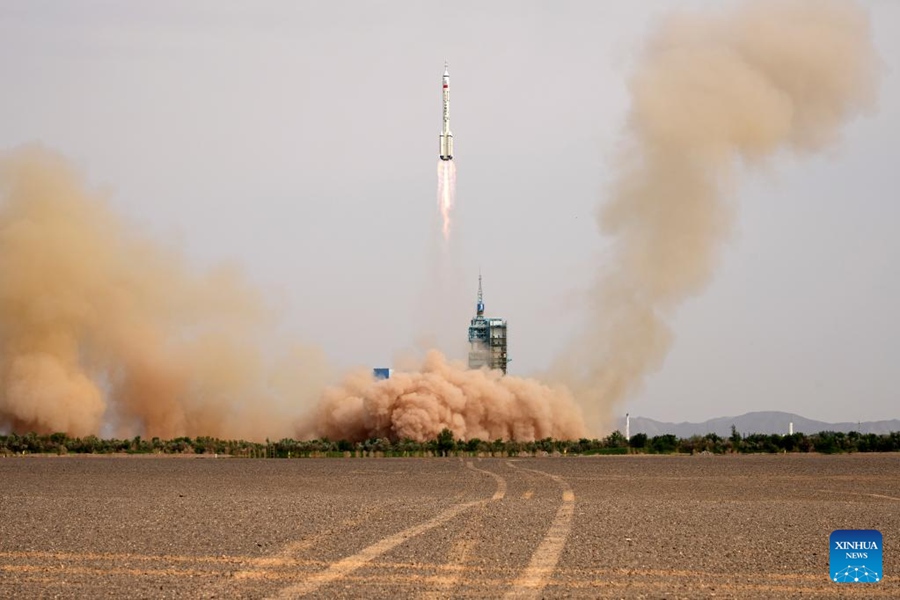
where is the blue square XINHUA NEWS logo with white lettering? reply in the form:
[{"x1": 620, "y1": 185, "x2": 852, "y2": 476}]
[{"x1": 828, "y1": 529, "x2": 884, "y2": 583}]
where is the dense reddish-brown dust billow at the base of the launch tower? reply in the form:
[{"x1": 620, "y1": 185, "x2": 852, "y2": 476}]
[{"x1": 301, "y1": 351, "x2": 584, "y2": 440}]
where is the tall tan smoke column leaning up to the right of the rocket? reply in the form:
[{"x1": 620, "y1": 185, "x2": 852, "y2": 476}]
[{"x1": 557, "y1": 0, "x2": 877, "y2": 428}]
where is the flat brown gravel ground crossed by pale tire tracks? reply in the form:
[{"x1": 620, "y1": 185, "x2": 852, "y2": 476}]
[{"x1": 0, "y1": 454, "x2": 900, "y2": 598}]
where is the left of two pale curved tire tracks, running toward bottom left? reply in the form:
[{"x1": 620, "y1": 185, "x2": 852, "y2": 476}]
[{"x1": 271, "y1": 462, "x2": 506, "y2": 600}]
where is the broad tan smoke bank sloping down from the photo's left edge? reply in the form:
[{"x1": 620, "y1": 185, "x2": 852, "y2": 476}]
[{"x1": 0, "y1": 147, "x2": 327, "y2": 439}]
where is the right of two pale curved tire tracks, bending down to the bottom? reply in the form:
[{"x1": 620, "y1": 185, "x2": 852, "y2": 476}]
[{"x1": 504, "y1": 461, "x2": 575, "y2": 599}]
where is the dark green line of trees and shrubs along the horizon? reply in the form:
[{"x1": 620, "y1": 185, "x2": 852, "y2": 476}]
[{"x1": 0, "y1": 426, "x2": 900, "y2": 458}]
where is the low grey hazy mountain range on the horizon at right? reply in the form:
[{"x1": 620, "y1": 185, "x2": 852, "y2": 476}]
[{"x1": 618, "y1": 411, "x2": 900, "y2": 438}]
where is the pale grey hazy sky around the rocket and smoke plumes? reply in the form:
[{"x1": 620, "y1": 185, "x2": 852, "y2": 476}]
[{"x1": 0, "y1": 0, "x2": 900, "y2": 421}]
